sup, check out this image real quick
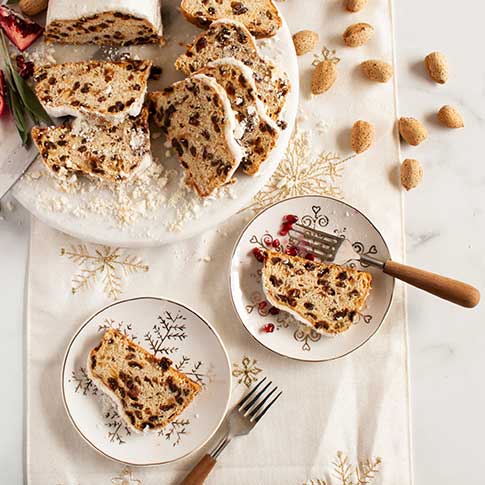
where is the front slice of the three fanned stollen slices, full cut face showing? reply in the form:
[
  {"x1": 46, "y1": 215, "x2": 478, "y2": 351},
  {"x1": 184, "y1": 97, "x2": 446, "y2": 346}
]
[{"x1": 148, "y1": 74, "x2": 244, "y2": 197}]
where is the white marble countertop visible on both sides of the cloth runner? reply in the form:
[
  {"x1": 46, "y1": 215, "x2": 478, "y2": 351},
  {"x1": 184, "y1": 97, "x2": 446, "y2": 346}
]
[{"x1": 0, "y1": 0, "x2": 485, "y2": 485}]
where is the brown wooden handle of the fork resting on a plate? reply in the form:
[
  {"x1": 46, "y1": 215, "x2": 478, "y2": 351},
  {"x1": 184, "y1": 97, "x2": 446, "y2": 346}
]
[{"x1": 384, "y1": 261, "x2": 480, "y2": 308}]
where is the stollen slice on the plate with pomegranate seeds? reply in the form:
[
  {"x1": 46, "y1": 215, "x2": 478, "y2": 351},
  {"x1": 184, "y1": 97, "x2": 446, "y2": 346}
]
[{"x1": 263, "y1": 251, "x2": 372, "y2": 335}]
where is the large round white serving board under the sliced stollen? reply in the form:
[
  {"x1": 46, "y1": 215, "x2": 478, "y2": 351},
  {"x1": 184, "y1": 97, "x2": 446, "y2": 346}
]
[{"x1": 8, "y1": 0, "x2": 299, "y2": 247}]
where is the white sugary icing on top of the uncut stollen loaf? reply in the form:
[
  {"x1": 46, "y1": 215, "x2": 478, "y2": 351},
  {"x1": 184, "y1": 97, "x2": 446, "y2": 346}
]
[{"x1": 46, "y1": 0, "x2": 163, "y2": 36}]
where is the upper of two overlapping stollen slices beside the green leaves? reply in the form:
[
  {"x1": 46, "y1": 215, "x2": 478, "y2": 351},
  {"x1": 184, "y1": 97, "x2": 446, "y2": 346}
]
[{"x1": 34, "y1": 60, "x2": 152, "y2": 121}]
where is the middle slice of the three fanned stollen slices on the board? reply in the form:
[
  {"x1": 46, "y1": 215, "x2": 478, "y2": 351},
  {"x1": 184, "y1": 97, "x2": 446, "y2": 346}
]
[{"x1": 197, "y1": 58, "x2": 279, "y2": 175}]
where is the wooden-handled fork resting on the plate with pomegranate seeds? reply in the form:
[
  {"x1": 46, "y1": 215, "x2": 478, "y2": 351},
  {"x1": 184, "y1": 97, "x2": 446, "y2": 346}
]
[{"x1": 289, "y1": 223, "x2": 480, "y2": 308}]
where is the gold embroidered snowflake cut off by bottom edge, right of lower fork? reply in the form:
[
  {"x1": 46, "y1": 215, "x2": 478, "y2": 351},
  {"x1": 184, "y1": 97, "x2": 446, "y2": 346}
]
[{"x1": 303, "y1": 451, "x2": 381, "y2": 485}]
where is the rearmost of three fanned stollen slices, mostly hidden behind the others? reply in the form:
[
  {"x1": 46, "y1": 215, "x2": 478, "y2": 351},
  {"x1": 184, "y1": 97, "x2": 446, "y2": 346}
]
[{"x1": 175, "y1": 19, "x2": 290, "y2": 120}]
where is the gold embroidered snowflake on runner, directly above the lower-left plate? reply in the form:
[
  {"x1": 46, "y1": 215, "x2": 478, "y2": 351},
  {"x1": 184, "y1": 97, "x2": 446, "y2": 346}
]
[{"x1": 61, "y1": 244, "x2": 150, "y2": 300}]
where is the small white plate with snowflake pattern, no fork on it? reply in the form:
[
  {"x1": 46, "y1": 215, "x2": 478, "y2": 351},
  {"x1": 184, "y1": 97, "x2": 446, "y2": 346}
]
[{"x1": 62, "y1": 297, "x2": 231, "y2": 466}]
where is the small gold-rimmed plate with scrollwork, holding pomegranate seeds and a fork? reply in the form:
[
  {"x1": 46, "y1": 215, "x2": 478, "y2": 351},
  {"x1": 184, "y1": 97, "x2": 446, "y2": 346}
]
[{"x1": 230, "y1": 196, "x2": 394, "y2": 362}]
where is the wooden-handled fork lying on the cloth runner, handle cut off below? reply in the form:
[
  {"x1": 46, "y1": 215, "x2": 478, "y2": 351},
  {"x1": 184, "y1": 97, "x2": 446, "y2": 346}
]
[{"x1": 181, "y1": 377, "x2": 283, "y2": 485}]
